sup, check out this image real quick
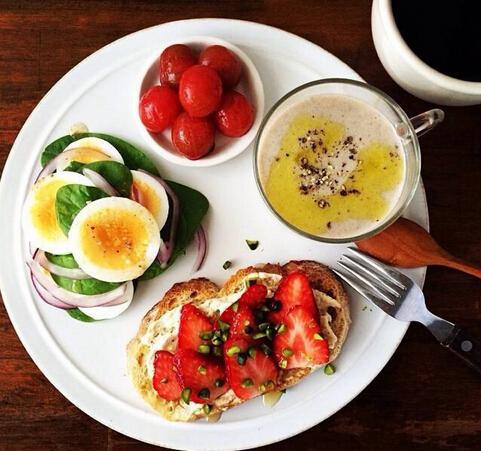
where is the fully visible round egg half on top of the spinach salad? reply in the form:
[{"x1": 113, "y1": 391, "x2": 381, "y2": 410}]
[{"x1": 68, "y1": 197, "x2": 161, "y2": 282}]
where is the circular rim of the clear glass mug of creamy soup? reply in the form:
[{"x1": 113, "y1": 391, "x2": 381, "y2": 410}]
[{"x1": 253, "y1": 78, "x2": 421, "y2": 244}]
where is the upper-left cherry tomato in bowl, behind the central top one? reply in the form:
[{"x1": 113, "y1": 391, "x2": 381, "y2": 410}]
[{"x1": 159, "y1": 44, "x2": 197, "y2": 88}]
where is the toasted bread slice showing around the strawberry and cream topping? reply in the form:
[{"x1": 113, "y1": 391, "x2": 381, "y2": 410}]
[{"x1": 127, "y1": 260, "x2": 351, "y2": 421}]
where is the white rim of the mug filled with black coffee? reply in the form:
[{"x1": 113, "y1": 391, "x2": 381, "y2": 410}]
[{"x1": 375, "y1": 0, "x2": 481, "y2": 95}]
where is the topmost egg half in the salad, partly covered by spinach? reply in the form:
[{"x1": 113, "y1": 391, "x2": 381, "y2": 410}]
[{"x1": 57, "y1": 137, "x2": 124, "y2": 171}]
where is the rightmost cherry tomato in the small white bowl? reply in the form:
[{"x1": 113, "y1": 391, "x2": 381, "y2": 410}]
[{"x1": 215, "y1": 91, "x2": 254, "y2": 138}]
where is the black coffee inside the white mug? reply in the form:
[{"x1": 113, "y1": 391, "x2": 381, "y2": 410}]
[{"x1": 392, "y1": 0, "x2": 481, "y2": 81}]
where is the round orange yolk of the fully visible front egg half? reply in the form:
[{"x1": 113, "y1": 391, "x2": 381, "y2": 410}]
[{"x1": 80, "y1": 208, "x2": 149, "y2": 269}]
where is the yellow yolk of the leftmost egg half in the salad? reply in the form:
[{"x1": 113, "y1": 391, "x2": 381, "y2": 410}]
[{"x1": 30, "y1": 180, "x2": 66, "y2": 241}]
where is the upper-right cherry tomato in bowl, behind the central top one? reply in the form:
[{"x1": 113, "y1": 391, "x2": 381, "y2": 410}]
[{"x1": 199, "y1": 45, "x2": 242, "y2": 88}]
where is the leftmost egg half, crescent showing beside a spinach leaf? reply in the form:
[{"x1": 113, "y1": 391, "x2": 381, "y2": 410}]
[{"x1": 23, "y1": 171, "x2": 93, "y2": 255}]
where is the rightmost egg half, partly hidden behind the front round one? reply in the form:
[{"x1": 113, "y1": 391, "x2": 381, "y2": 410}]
[{"x1": 130, "y1": 171, "x2": 169, "y2": 230}]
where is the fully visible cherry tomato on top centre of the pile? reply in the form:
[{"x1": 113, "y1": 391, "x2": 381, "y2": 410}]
[{"x1": 179, "y1": 64, "x2": 222, "y2": 117}]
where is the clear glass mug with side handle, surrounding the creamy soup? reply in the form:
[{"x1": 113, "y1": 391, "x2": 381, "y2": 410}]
[{"x1": 254, "y1": 78, "x2": 444, "y2": 243}]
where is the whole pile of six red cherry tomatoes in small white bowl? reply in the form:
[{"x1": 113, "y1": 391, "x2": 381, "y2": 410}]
[{"x1": 139, "y1": 44, "x2": 255, "y2": 160}]
